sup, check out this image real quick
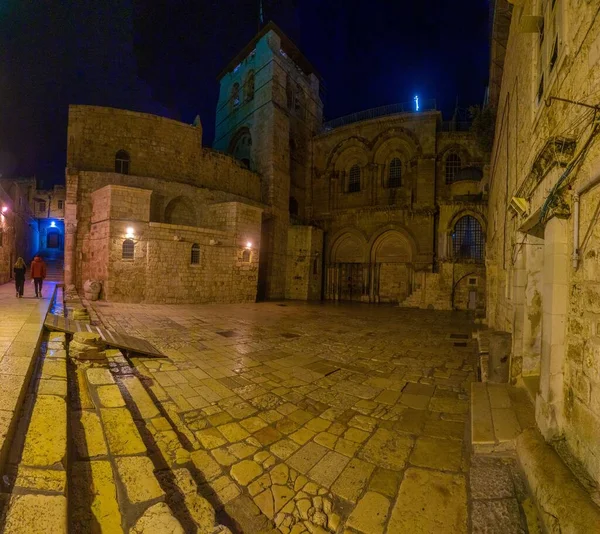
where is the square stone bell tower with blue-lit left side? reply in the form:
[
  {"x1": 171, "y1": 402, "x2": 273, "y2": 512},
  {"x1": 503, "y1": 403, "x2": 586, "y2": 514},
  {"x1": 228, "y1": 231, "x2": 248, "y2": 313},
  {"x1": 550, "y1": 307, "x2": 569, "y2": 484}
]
[{"x1": 213, "y1": 22, "x2": 323, "y2": 299}]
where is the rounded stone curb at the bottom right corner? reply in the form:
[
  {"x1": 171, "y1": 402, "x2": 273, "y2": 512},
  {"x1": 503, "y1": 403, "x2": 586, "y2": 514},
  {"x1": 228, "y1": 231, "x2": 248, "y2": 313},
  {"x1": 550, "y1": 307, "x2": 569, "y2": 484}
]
[{"x1": 517, "y1": 429, "x2": 600, "y2": 534}]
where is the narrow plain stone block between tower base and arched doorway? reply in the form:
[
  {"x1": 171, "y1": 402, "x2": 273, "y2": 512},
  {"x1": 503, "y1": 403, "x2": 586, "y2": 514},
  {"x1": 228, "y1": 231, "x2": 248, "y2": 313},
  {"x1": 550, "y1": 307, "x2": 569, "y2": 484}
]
[{"x1": 285, "y1": 225, "x2": 323, "y2": 300}]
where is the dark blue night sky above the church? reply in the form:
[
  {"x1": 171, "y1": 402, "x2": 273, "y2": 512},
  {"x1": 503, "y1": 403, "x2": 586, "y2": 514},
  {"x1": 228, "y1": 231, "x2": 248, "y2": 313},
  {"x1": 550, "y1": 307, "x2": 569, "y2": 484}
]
[{"x1": 0, "y1": 0, "x2": 489, "y2": 186}]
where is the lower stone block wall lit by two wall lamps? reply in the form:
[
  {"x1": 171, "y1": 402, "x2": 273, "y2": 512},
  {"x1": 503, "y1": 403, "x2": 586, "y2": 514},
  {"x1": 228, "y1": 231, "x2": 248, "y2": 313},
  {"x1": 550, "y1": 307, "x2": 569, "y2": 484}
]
[{"x1": 81, "y1": 185, "x2": 261, "y2": 304}]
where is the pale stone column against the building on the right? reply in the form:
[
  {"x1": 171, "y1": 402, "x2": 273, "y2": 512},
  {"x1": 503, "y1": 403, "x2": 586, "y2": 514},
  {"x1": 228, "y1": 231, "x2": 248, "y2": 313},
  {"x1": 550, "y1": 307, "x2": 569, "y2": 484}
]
[{"x1": 535, "y1": 217, "x2": 569, "y2": 439}]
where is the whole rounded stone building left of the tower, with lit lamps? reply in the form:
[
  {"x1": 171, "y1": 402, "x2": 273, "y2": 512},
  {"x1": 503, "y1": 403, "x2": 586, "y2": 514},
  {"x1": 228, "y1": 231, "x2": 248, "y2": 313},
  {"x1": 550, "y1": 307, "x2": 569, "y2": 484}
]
[{"x1": 65, "y1": 106, "x2": 262, "y2": 303}]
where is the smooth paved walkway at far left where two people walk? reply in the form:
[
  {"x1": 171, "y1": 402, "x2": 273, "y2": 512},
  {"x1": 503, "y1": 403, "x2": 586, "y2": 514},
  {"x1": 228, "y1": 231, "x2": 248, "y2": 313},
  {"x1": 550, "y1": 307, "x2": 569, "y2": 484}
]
[{"x1": 0, "y1": 283, "x2": 55, "y2": 478}]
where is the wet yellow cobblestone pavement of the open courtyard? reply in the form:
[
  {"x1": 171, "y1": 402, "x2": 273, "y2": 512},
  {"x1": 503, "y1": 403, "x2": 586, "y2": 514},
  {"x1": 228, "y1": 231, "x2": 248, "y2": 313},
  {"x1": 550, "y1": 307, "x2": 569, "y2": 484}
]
[{"x1": 89, "y1": 302, "x2": 527, "y2": 534}]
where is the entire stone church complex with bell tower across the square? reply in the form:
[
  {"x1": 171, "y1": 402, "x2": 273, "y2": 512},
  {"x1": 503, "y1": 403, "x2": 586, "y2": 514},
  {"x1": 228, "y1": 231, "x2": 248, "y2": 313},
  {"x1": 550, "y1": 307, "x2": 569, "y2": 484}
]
[{"x1": 65, "y1": 24, "x2": 488, "y2": 309}]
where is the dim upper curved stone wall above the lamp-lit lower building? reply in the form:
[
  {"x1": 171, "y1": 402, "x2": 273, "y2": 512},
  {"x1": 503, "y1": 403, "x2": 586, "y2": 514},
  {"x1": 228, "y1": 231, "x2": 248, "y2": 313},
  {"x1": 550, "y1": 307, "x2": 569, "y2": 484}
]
[{"x1": 67, "y1": 106, "x2": 260, "y2": 200}]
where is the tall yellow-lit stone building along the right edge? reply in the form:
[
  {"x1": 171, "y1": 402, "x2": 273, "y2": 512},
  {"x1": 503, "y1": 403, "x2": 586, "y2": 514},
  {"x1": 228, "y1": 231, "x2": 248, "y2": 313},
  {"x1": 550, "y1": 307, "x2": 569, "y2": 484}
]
[{"x1": 486, "y1": 0, "x2": 600, "y2": 481}]
